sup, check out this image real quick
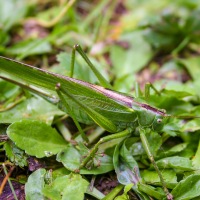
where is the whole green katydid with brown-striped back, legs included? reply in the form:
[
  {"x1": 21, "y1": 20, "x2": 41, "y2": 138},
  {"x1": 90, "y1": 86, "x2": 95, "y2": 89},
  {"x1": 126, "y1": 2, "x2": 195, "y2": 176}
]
[{"x1": 0, "y1": 45, "x2": 173, "y2": 199}]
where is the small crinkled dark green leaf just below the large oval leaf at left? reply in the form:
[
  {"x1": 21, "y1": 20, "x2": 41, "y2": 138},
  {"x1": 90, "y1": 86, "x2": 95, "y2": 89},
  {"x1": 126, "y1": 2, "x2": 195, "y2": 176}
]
[{"x1": 4, "y1": 141, "x2": 28, "y2": 167}]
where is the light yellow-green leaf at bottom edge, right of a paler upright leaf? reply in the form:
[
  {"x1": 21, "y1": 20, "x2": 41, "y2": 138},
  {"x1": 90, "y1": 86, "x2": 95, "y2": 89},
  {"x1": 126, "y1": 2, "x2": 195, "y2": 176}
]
[{"x1": 43, "y1": 174, "x2": 89, "y2": 200}]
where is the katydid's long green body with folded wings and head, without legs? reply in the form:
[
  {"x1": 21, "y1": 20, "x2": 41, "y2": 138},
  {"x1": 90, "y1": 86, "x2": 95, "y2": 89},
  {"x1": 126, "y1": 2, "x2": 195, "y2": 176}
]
[{"x1": 0, "y1": 57, "x2": 166, "y2": 132}]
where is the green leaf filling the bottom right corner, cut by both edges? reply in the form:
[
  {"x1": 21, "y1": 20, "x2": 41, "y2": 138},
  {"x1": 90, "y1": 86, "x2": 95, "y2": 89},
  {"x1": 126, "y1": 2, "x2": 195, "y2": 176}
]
[{"x1": 171, "y1": 174, "x2": 200, "y2": 200}]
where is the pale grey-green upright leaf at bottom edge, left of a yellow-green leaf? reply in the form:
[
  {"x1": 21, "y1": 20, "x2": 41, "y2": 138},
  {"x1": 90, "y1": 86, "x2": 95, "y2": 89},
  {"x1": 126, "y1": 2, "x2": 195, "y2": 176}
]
[{"x1": 25, "y1": 168, "x2": 46, "y2": 200}]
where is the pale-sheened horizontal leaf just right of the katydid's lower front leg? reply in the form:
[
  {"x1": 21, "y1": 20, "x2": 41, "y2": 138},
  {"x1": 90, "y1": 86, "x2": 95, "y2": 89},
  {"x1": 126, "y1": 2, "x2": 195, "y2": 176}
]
[{"x1": 156, "y1": 156, "x2": 193, "y2": 170}]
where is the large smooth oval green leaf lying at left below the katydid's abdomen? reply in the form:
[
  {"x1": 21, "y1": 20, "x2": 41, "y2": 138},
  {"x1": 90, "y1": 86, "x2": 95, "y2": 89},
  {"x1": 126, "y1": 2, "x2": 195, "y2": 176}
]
[{"x1": 7, "y1": 120, "x2": 67, "y2": 158}]
